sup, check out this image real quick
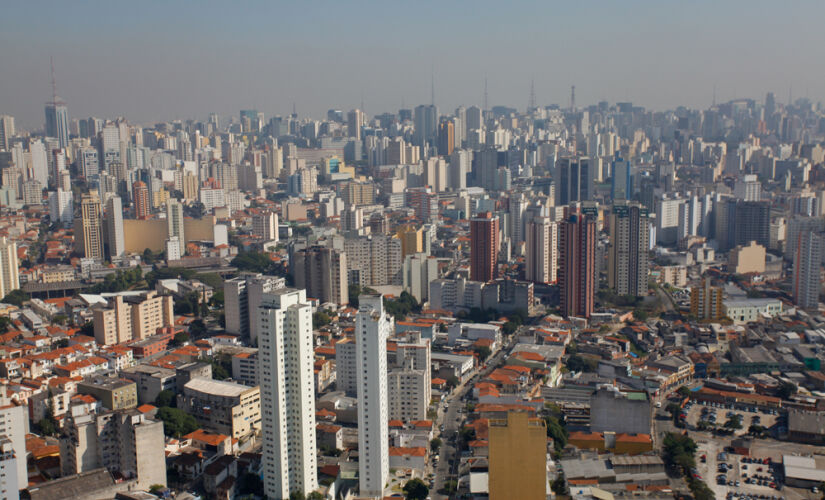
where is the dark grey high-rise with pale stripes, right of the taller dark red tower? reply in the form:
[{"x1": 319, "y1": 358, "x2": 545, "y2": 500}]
[{"x1": 607, "y1": 201, "x2": 650, "y2": 297}]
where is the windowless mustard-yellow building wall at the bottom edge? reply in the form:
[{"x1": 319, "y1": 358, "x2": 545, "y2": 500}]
[{"x1": 489, "y1": 411, "x2": 548, "y2": 500}]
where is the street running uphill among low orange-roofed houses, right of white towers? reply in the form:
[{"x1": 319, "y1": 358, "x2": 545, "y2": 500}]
[{"x1": 430, "y1": 326, "x2": 528, "y2": 500}]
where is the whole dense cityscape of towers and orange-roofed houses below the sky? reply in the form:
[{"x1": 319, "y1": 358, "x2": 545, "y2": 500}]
[{"x1": 0, "y1": 93, "x2": 825, "y2": 500}]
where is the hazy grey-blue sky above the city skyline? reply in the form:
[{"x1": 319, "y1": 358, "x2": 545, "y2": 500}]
[{"x1": 0, "y1": 0, "x2": 825, "y2": 128}]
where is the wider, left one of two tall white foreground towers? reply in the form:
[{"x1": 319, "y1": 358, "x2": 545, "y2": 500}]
[{"x1": 255, "y1": 288, "x2": 318, "y2": 498}]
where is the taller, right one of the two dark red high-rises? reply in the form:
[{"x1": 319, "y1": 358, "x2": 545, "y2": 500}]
[{"x1": 559, "y1": 205, "x2": 597, "y2": 318}]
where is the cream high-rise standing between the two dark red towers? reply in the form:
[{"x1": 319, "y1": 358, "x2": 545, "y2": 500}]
[{"x1": 524, "y1": 216, "x2": 559, "y2": 283}]
